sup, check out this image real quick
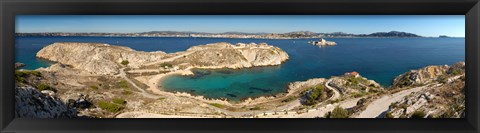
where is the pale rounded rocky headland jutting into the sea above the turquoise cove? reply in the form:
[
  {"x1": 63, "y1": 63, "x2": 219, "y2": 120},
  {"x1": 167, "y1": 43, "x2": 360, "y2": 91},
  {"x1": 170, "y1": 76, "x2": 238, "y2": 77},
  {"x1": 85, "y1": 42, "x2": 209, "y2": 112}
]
[{"x1": 173, "y1": 42, "x2": 288, "y2": 69}]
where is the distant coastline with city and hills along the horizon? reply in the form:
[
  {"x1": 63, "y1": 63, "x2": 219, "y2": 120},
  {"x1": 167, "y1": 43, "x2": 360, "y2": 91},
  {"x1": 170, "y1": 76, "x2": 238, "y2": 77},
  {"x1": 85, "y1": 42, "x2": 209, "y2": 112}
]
[{"x1": 16, "y1": 31, "x2": 460, "y2": 39}]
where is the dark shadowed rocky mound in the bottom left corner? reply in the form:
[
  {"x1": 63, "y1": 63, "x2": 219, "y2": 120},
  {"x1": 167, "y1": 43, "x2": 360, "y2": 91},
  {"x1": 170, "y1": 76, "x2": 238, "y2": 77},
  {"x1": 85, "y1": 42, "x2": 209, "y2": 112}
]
[{"x1": 15, "y1": 86, "x2": 77, "y2": 118}]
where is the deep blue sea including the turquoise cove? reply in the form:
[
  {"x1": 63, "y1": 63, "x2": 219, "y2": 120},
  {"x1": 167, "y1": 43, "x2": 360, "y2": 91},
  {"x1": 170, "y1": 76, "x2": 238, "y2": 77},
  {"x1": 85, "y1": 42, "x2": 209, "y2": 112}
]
[{"x1": 16, "y1": 37, "x2": 465, "y2": 100}]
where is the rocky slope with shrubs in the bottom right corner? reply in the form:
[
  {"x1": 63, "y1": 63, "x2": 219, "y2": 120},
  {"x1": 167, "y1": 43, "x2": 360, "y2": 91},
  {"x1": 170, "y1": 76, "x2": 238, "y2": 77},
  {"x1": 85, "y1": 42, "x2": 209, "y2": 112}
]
[{"x1": 385, "y1": 62, "x2": 465, "y2": 118}]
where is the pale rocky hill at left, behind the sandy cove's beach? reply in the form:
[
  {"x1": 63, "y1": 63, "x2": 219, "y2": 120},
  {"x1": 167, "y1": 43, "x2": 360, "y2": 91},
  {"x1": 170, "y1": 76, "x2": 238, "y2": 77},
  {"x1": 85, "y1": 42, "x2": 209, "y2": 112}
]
[{"x1": 37, "y1": 42, "x2": 166, "y2": 75}]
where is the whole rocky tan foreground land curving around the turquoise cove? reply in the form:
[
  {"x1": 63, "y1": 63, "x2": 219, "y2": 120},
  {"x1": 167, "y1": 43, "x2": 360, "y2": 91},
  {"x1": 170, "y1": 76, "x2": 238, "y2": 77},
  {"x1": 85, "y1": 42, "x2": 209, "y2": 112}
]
[{"x1": 15, "y1": 42, "x2": 465, "y2": 118}]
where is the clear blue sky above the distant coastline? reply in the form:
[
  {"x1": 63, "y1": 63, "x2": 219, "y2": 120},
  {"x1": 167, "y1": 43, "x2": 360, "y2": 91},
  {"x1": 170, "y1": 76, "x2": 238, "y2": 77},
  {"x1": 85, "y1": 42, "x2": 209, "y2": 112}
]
[{"x1": 16, "y1": 15, "x2": 465, "y2": 37}]
